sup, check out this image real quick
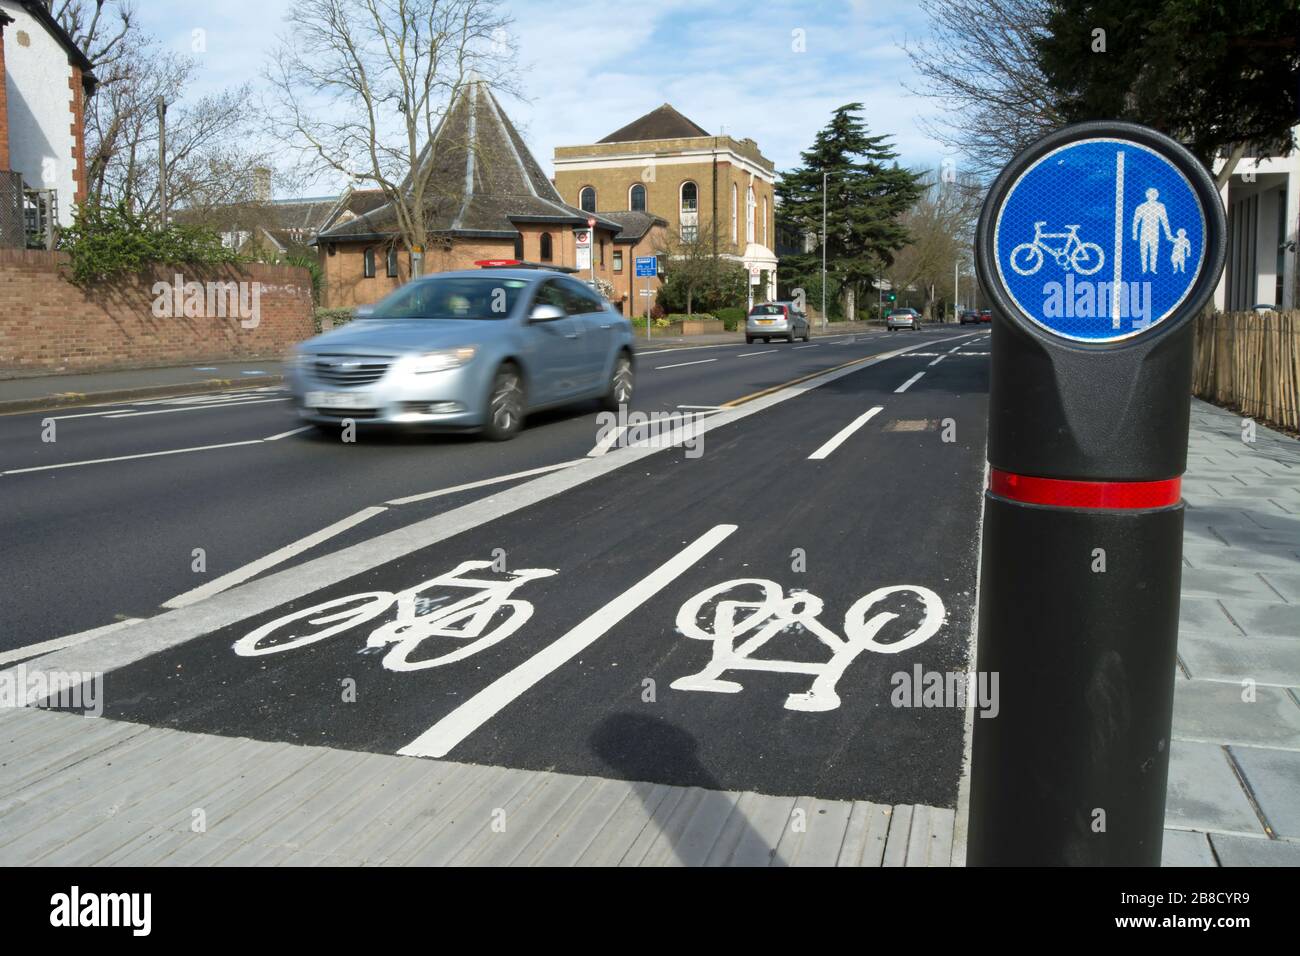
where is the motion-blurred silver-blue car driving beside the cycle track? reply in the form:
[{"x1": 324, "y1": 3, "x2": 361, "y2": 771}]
[{"x1": 287, "y1": 269, "x2": 633, "y2": 441}]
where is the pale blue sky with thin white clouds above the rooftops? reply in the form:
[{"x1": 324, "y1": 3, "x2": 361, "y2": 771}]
[{"x1": 137, "y1": 0, "x2": 949, "y2": 198}]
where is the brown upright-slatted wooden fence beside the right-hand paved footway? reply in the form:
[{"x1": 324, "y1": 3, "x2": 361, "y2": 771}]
[{"x1": 1192, "y1": 312, "x2": 1300, "y2": 431}]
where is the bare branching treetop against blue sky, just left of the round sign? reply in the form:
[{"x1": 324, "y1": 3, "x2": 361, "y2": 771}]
[{"x1": 904, "y1": 0, "x2": 1063, "y2": 177}]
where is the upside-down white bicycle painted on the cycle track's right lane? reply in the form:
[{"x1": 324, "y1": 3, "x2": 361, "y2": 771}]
[{"x1": 671, "y1": 578, "x2": 946, "y2": 711}]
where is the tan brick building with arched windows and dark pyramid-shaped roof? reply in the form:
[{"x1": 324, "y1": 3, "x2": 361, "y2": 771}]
[{"x1": 555, "y1": 103, "x2": 776, "y2": 303}]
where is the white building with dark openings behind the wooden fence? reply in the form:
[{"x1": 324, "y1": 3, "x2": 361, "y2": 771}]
[{"x1": 1214, "y1": 127, "x2": 1300, "y2": 312}]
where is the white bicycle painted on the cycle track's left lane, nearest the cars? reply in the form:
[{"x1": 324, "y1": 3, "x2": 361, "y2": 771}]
[{"x1": 234, "y1": 561, "x2": 555, "y2": 671}]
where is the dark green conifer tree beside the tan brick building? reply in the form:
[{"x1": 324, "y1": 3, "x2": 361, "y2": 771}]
[{"x1": 776, "y1": 103, "x2": 920, "y2": 319}]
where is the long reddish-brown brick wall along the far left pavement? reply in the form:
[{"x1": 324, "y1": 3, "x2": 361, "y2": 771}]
[{"x1": 0, "y1": 250, "x2": 312, "y2": 377}]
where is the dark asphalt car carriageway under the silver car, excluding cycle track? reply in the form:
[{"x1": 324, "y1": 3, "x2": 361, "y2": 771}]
[{"x1": 0, "y1": 326, "x2": 965, "y2": 652}]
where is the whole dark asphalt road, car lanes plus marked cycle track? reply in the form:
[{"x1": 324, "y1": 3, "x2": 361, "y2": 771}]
[{"x1": 0, "y1": 326, "x2": 988, "y2": 806}]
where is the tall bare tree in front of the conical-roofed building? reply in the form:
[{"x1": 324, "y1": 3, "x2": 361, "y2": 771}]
[{"x1": 265, "y1": 0, "x2": 515, "y2": 274}]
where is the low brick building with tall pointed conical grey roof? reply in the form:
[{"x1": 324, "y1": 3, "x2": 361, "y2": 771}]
[{"x1": 316, "y1": 81, "x2": 623, "y2": 307}]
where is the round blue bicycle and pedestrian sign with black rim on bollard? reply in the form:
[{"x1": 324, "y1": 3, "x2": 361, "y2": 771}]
[{"x1": 979, "y1": 122, "x2": 1223, "y2": 345}]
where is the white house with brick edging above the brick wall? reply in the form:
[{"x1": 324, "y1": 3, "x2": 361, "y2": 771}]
[{"x1": 0, "y1": 0, "x2": 95, "y2": 238}]
